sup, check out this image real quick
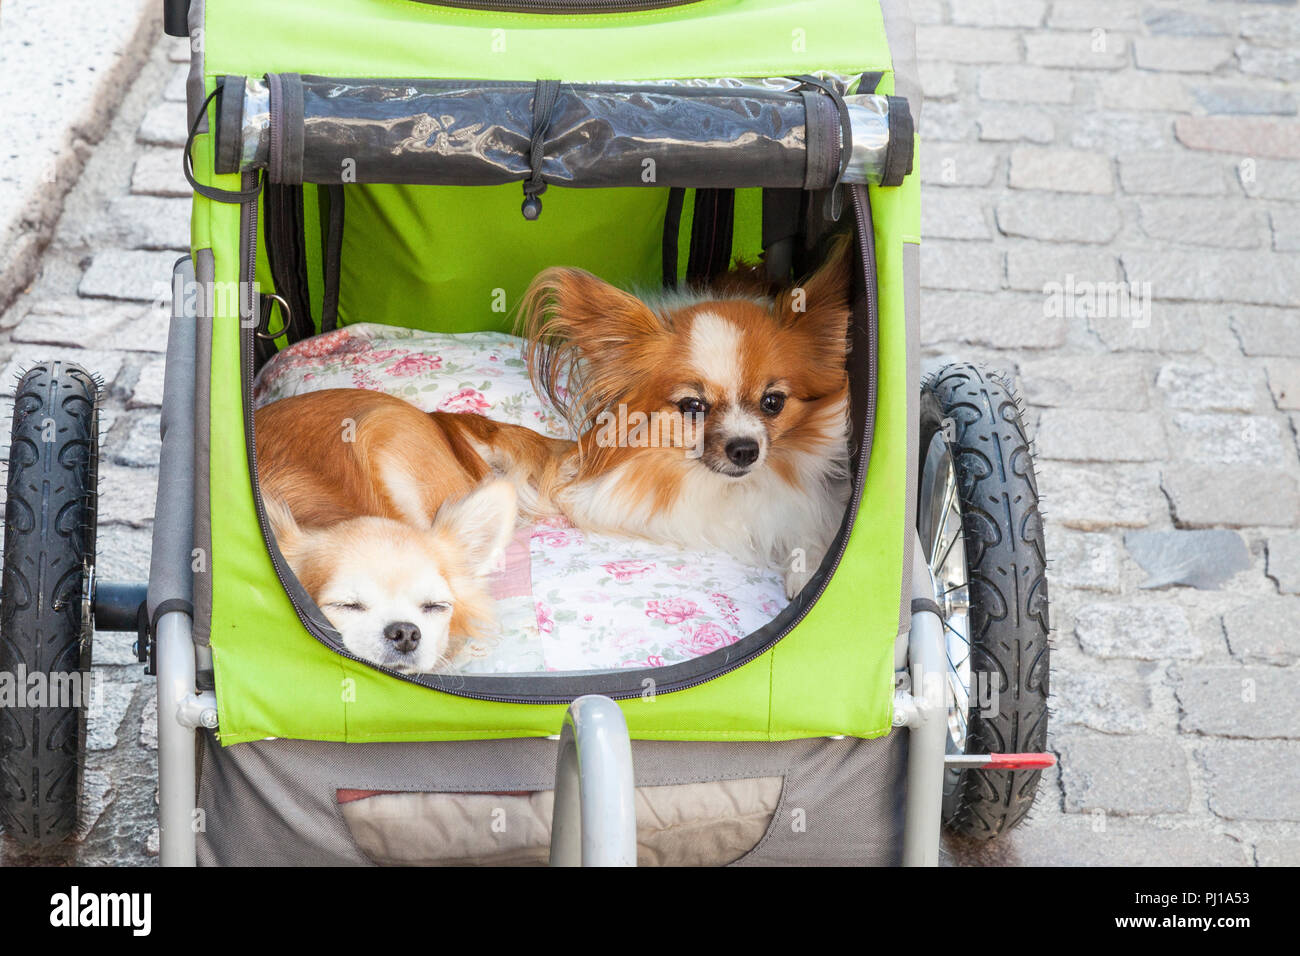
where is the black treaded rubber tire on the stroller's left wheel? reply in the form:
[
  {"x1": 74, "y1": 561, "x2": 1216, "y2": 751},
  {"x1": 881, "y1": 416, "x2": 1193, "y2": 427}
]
[{"x1": 0, "y1": 362, "x2": 99, "y2": 849}]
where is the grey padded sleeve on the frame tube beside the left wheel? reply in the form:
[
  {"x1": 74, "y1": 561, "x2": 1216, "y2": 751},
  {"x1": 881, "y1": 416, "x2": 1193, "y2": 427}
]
[{"x1": 148, "y1": 256, "x2": 196, "y2": 620}]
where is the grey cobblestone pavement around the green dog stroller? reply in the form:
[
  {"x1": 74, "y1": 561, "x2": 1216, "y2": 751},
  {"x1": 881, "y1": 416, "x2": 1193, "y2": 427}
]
[{"x1": 0, "y1": 0, "x2": 1300, "y2": 865}]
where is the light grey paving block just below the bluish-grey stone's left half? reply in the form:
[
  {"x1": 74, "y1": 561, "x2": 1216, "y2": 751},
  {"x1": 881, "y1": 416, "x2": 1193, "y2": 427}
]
[{"x1": 1074, "y1": 602, "x2": 1205, "y2": 661}]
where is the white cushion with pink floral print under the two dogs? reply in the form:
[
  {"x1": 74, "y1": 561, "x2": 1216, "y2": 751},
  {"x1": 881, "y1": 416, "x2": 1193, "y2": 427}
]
[{"x1": 254, "y1": 324, "x2": 787, "y2": 674}]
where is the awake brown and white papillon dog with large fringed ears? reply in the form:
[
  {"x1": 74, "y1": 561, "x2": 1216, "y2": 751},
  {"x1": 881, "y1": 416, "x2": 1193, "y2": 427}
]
[{"x1": 520, "y1": 239, "x2": 852, "y2": 597}]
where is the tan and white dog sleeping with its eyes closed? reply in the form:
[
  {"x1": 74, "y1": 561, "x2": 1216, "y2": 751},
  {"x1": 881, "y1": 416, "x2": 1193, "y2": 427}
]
[{"x1": 255, "y1": 389, "x2": 550, "y2": 672}]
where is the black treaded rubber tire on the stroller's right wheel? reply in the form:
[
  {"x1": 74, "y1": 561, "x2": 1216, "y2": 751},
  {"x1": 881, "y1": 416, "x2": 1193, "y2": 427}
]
[{"x1": 918, "y1": 364, "x2": 1050, "y2": 840}]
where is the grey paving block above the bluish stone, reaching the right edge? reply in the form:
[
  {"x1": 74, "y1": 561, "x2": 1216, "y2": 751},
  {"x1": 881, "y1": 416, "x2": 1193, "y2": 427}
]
[{"x1": 1160, "y1": 463, "x2": 1300, "y2": 528}]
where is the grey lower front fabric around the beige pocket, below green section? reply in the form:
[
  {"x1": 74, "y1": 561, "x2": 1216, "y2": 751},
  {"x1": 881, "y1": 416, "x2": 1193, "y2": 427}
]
[{"x1": 199, "y1": 732, "x2": 906, "y2": 865}]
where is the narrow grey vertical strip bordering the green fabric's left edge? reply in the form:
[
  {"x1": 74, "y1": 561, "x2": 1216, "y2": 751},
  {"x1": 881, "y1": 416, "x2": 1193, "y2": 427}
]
[{"x1": 192, "y1": 248, "x2": 217, "y2": 646}]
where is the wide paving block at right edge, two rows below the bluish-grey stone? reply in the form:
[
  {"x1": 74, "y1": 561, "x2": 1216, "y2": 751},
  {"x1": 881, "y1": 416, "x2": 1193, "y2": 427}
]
[{"x1": 1174, "y1": 665, "x2": 1300, "y2": 740}]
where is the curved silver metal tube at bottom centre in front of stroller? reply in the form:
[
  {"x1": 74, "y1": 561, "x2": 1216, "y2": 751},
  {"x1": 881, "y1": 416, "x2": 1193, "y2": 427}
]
[{"x1": 551, "y1": 695, "x2": 637, "y2": 866}]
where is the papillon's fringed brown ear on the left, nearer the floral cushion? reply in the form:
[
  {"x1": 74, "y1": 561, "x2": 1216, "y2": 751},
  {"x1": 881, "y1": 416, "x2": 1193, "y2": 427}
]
[{"x1": 516, "y1": 268, "x2": 664, "y2": 432}]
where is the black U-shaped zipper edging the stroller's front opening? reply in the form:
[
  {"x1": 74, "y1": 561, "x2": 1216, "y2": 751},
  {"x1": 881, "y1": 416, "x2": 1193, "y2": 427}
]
[{"x1": 239, "y1": 184, "x2": 880, "y2": 704}]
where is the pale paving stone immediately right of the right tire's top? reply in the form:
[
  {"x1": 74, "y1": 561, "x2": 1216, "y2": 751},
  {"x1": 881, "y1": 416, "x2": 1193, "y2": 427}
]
[{"x1": 1021, "y1": 354, "x2": 1149, "y2": 411}]
